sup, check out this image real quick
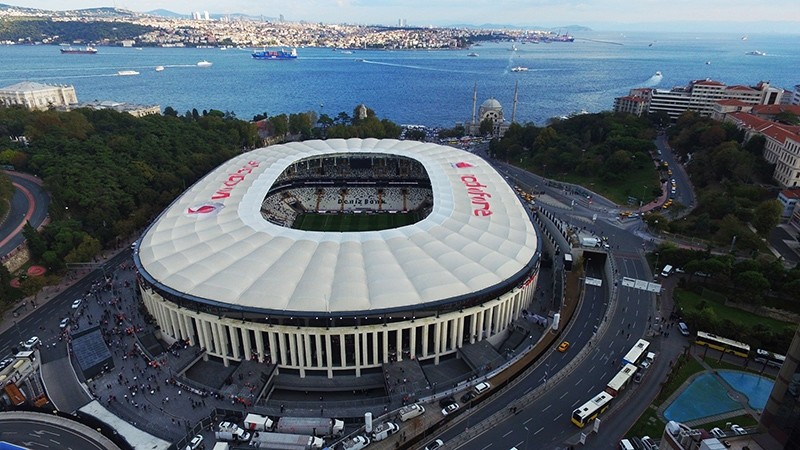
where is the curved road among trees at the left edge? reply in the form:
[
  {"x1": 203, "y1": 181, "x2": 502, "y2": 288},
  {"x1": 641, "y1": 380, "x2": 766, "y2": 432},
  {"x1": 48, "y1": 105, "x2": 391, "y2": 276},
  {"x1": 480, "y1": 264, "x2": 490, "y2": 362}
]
[{"x1": 0, "y1": 170, "x2": 50, "y2": 258}]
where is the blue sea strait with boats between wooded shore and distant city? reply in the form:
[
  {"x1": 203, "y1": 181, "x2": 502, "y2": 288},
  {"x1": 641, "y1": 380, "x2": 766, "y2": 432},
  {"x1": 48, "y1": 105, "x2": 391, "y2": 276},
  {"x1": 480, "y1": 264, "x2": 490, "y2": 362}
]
[{"x1": 0, "y1": 31, "x2": 800, "y2": 127}]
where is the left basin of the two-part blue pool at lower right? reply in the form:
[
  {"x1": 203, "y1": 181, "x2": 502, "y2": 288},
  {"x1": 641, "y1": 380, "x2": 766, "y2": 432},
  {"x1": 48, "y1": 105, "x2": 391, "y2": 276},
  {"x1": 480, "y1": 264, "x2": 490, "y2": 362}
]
[{"x1": 664, "y1": 373, "x2": 742, "y2": 422}]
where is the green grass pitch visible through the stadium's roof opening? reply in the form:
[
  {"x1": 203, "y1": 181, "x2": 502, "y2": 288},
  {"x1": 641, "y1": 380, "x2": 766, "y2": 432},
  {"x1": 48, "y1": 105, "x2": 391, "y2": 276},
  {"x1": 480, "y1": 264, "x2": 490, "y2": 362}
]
[{"x1": 294, "y1": 212, "x2": 419, "y2": 232}]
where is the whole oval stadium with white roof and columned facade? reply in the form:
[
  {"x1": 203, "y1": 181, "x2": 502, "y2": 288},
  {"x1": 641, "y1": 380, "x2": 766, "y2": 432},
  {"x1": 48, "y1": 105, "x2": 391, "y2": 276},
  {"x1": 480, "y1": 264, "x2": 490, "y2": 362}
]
[{"x1": 134, "y1": 139, "x2": 541, "y2": 378}]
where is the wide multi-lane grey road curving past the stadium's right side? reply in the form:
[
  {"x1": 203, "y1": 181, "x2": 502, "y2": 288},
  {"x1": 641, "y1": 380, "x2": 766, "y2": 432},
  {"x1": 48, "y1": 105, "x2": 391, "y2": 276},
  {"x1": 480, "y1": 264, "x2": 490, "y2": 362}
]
[{"x1": 429, "y1": 143, "x2": 691, "y2": 450}]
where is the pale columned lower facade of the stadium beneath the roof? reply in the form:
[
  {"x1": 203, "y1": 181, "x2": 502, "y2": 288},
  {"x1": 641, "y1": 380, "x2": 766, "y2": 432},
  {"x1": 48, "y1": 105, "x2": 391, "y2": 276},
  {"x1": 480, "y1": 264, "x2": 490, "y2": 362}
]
[{"x1": 141, "y1": 276, "x2": 537, "y2": 378}]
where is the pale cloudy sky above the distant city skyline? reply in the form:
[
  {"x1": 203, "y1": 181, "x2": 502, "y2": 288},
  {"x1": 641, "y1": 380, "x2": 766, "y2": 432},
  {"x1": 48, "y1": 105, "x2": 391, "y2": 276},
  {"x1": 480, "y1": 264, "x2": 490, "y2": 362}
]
[{"x1": 9, "y1": 0, "x2": 800, "y2": 33}]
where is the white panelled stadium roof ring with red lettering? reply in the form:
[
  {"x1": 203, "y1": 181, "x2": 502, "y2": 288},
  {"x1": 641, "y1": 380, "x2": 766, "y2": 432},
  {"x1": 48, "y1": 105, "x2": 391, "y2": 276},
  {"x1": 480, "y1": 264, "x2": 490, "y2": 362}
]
[{"x1": 137, "y1": 139, "x2": 538, "y2": 315}]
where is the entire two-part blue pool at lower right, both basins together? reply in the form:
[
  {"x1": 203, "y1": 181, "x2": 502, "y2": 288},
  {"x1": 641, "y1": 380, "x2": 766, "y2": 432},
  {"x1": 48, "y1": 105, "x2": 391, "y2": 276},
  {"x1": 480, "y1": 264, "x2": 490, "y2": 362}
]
[{"x1": 664, "y1": 370, "x2": 774, "y2": 422}]
